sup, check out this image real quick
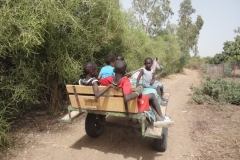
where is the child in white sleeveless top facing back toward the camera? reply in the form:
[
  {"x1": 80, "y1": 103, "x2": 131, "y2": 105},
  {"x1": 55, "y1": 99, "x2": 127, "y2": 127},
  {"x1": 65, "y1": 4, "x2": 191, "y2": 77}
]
[{"x1": 136, "y1": 57, "x2": 167, "y2": 106}]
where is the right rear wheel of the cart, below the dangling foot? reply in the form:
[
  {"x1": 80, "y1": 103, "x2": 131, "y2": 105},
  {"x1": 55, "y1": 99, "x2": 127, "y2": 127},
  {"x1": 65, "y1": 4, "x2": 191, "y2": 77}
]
[{"x1": 154, "y1": 128, "x2": 168, "y2": 152}]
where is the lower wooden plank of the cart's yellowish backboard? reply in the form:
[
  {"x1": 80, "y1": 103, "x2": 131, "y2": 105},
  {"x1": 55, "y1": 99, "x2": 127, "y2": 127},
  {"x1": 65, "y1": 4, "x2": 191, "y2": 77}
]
[{"x1": 69, "y1": 95, "x2": 138, "y2": 113}]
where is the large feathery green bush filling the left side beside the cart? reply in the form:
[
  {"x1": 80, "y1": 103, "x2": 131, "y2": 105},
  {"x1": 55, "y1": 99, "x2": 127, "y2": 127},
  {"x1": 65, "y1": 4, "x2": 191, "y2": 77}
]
[{"x1": 0, "y1": 0, "x2": 124, "y2": 146}]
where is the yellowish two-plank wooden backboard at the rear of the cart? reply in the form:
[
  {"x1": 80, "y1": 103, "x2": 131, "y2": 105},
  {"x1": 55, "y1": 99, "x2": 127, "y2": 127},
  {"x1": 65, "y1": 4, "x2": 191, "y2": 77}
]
[{"x1": 66, "y1": 85, "x2": 138, "y2": 113}]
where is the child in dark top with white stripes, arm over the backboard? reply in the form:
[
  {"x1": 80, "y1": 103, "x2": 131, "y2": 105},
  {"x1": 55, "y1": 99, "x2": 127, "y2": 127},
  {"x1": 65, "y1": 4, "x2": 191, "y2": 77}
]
[{"x1": 78, "y1": 62, "x2": 116, "y2": 98}]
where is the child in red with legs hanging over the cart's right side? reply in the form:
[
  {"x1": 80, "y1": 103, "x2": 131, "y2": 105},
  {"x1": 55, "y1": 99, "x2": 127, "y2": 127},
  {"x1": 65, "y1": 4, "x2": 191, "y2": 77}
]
[{"x1": 100, "y1": 61, "x2": 174, "y2": 127}]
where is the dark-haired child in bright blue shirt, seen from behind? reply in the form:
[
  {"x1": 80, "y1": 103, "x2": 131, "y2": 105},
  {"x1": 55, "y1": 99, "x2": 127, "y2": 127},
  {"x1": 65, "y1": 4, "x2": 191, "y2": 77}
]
[{"x1": 98, "y1": 54, "x2": 116, "y2": 79}]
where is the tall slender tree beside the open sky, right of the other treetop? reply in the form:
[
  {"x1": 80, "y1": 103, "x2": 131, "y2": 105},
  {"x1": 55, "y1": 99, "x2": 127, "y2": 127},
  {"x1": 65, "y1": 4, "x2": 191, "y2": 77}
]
[{"x1": 177, "y1": 0, "x2": 204, "y2": 59}]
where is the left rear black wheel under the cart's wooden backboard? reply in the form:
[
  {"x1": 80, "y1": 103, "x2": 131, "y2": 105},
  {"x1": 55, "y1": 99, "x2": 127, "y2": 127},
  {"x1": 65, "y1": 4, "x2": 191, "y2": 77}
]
[{"x1": 85, "y1": 113, "x2": 105, "y2": 138}]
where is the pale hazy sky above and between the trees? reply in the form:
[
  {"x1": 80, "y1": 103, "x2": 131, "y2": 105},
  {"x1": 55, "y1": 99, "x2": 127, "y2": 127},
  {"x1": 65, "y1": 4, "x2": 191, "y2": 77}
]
[{"x1": 120, "y1": 0, "x2": 240, "y2": 57}]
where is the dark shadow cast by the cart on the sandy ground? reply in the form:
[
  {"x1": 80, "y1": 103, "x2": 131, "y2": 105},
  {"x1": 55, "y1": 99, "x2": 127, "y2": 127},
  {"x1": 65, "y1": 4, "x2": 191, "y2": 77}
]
[{"x1": 71, "y1": 118, "x2": 162, "y2": 160}]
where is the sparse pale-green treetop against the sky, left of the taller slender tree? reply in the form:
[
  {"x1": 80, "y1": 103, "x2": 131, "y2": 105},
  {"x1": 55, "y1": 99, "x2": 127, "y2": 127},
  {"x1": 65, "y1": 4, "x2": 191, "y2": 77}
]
[{"x1": 132, "y1": 0, "x2": 173, "y2": 37}]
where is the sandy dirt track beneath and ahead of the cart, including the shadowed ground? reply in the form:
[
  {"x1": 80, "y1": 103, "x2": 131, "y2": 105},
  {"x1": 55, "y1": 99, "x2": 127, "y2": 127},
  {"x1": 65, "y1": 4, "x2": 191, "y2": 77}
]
[{"x1": 0, "y1": 69, "x2": 240, "y2": 160}]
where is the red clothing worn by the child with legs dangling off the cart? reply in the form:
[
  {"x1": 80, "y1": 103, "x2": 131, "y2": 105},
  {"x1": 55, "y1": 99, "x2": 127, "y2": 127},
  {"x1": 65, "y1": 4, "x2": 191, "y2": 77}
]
[{"x1": 99, "y1": 76, "x2": 150, "y2": 112}]
